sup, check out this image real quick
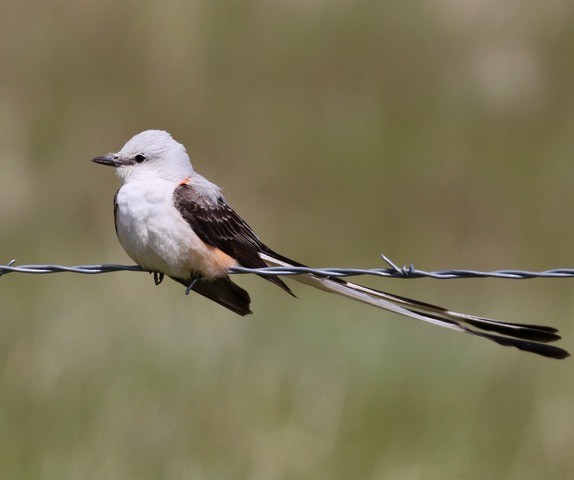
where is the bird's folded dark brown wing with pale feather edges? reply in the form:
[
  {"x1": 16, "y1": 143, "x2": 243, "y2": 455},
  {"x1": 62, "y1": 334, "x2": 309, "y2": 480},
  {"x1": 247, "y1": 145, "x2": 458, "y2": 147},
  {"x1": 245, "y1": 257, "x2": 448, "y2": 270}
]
[{"x1": 173, "y1": 184, "x2": 294, "y2": 296}]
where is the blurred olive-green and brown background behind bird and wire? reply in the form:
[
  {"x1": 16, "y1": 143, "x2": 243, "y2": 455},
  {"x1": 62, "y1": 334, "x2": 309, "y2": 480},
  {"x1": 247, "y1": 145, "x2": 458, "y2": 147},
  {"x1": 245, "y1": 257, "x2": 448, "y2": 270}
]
[{"x1": 0, "y1": 0, "x2": 574, "y2": 480}]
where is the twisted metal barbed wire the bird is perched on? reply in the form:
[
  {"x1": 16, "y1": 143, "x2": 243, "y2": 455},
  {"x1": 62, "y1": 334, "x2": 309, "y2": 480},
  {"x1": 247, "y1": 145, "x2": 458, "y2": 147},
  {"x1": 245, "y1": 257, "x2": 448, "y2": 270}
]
[{"x1": 0, "y1": 255, "x2": 574, "y2": 284}]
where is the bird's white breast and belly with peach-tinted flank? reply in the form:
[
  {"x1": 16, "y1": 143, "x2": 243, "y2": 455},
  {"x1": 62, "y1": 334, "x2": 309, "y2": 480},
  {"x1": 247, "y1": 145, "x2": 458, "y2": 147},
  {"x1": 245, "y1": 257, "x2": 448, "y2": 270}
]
[{"x1": 116, "y1": 186, "x2": 235, "y2": 279}]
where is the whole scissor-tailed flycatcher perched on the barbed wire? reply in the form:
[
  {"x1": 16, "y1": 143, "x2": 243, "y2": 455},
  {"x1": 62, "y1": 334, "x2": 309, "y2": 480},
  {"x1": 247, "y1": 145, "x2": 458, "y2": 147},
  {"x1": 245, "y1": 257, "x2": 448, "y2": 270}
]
[{"x1": 93, "y1": 130, "x2": 569, "y2": 358}]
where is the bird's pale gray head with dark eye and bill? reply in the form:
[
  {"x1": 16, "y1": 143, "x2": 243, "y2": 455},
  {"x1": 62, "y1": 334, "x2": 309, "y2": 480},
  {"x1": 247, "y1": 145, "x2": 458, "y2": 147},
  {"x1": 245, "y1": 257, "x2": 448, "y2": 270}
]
[{"x1": 92, "y1": 130, "x2": 193, "y2": 183}]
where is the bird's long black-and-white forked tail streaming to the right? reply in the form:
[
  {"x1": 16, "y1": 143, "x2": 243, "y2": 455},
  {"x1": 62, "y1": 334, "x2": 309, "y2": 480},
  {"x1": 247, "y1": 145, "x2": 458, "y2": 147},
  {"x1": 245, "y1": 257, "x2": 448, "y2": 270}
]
[{"x1": 259, "y1": 251, "x2": 570, "y2": 359}]
